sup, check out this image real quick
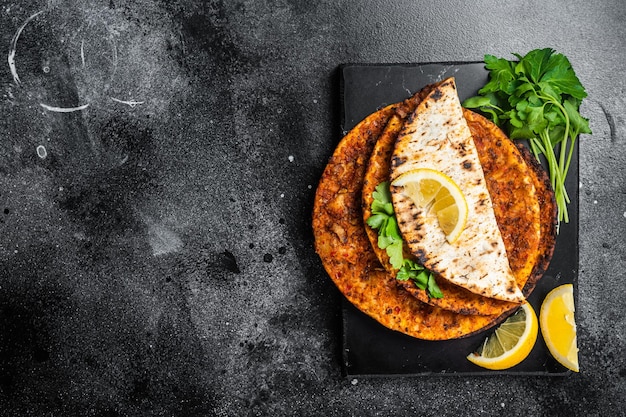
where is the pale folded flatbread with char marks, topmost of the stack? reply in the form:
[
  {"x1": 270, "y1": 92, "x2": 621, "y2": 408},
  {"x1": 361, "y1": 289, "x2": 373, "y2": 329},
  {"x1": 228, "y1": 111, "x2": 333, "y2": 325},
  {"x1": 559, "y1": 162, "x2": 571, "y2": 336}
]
[{"x1": 390, "y1": 78, "x2": 532, "y2": 303}]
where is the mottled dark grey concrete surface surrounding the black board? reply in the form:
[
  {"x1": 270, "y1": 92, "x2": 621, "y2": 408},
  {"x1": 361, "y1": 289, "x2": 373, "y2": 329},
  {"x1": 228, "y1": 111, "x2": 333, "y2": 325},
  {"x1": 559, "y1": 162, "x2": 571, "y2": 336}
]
[{"x1": 0, "y1": 0, "x2": 626, "y2": 416}]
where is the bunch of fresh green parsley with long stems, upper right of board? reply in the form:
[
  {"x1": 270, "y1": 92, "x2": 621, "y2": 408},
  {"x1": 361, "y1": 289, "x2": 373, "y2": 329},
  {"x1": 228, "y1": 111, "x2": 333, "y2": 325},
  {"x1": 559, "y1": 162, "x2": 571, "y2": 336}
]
[{"x1": 463, "y1": 48, "x2": 591, "y2": 231}]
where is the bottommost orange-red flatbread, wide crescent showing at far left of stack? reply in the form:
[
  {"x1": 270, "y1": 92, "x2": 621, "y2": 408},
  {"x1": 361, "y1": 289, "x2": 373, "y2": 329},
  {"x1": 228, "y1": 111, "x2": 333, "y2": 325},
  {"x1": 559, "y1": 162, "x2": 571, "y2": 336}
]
[{"x1": 313, "y1": 106, "x2": 504, "y2": 340}]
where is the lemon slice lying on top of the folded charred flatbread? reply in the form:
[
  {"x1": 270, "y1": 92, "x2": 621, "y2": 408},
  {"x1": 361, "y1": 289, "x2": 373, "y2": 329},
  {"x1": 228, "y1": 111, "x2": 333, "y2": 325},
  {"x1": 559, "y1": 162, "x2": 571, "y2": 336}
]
[{"x1": 391, "y1": 168, "x2": 468, "y2": 243}]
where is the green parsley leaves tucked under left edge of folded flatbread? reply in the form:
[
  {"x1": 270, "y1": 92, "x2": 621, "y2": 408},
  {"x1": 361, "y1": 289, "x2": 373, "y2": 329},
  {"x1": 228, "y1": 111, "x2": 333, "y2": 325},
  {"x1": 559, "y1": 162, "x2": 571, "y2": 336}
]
[{"x1": 367, "y1": 182, "x2": 443, "y2": 298}]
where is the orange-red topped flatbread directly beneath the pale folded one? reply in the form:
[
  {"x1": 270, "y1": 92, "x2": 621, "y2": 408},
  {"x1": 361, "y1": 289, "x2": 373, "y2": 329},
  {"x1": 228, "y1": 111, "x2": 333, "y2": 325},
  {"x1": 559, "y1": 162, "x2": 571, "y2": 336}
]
[{"x1": 363, "y1": 102, "x2": 556, "y2": 315}]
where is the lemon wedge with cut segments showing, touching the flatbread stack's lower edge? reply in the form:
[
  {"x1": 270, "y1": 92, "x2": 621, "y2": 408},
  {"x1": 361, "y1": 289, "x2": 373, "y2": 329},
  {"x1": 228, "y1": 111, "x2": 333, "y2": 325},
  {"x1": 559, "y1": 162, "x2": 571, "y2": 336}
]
[{"x1": 467, "y1": 302, "x2": 539, "y2": 370}]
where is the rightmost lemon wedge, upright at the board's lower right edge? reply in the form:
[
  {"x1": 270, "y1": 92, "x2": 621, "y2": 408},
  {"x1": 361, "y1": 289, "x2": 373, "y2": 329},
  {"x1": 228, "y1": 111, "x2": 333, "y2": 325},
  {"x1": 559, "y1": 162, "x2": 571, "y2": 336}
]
[{"x1": 539, "y1": 284, "x2": 578, "y2": 372}]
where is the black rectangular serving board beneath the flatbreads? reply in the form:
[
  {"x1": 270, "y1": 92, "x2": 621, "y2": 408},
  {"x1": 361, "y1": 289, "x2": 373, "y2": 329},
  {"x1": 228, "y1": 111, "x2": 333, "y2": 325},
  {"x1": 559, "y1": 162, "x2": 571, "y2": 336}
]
[{"x1": 339, "y1": 62, "x2": 579, "y2": 377}]
